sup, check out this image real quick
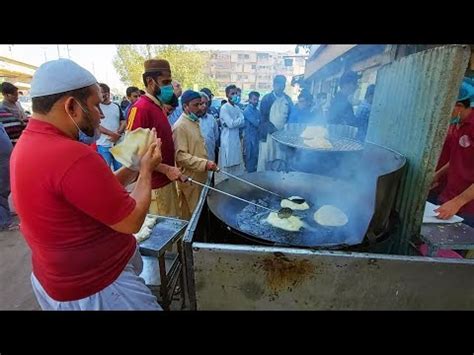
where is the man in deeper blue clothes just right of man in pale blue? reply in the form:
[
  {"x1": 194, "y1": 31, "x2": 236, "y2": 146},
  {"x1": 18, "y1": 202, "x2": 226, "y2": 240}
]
[{"x1": 244, "y1": 91, "x2": 260, "y2": 173}]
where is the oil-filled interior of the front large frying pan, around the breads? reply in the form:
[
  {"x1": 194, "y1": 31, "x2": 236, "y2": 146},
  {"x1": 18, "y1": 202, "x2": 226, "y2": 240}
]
[{"x1": 207, "y1": 171, "x2": 376, "y2": 247}]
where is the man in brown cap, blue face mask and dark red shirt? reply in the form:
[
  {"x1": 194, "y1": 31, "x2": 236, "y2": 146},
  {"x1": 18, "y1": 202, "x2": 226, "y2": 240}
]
[{"x1": 127, "y1": 59, "x2": 182, "y2": 217}]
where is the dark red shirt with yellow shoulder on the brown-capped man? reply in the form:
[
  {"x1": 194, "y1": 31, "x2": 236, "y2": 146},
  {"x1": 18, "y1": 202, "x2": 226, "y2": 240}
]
[{"x1": 127, "y1": 95, "x2": 174, "y2": 189}]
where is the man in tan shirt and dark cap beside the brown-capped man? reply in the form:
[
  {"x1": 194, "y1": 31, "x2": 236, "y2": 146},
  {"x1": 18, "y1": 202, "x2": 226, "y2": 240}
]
[{"x1": 173, "y1": 90, "x2": 217, "y2": 220}]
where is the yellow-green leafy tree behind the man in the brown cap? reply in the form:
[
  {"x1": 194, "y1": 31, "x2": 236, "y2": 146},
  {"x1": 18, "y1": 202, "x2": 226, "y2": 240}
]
[{"x1": 113, "y1": 45, "x2": 218, "y2": 96}]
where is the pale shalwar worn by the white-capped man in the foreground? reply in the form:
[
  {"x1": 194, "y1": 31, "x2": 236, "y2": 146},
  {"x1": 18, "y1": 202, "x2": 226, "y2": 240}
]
[{"x1": 31, "y1": 246, "x2": 162, "y2": 311}]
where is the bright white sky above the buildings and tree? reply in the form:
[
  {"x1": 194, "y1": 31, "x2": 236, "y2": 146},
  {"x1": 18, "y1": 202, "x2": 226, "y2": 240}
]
[{"x1": 0, "y1": 44, "x2": 296, "y2": 92}]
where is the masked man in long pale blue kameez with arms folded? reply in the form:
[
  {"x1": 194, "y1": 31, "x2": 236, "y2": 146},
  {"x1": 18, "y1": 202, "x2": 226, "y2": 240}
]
[{"x1": 216, "y1": 85, "x2": 245, "y2": 184}]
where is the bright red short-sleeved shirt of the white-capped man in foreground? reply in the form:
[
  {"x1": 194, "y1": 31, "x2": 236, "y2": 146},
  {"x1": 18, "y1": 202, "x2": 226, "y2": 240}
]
[{"x1": 10, "y1": 119, "x2": 136, "y2": 301}]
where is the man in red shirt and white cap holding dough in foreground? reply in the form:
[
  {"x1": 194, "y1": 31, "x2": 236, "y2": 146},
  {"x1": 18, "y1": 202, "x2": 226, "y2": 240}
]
[{"x1": 11, "y1": 59, "x2": 161, "y2": 310}]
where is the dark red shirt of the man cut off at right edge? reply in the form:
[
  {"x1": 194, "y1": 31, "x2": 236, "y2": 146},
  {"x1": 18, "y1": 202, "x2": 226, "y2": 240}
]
[{"x1": 439, "y1": 111, "x2": 474, "y2": 215}]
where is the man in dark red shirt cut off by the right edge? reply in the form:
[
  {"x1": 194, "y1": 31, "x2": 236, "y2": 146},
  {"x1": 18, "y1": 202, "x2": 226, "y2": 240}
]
[{"x1": 433, "y1": 82, "x2": 474, "y2": 226}]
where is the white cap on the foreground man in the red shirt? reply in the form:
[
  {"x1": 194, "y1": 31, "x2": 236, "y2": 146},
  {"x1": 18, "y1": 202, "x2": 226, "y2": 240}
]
[{"x1": 30, "y1": 58, "x2": 97, "y2": 98}]
